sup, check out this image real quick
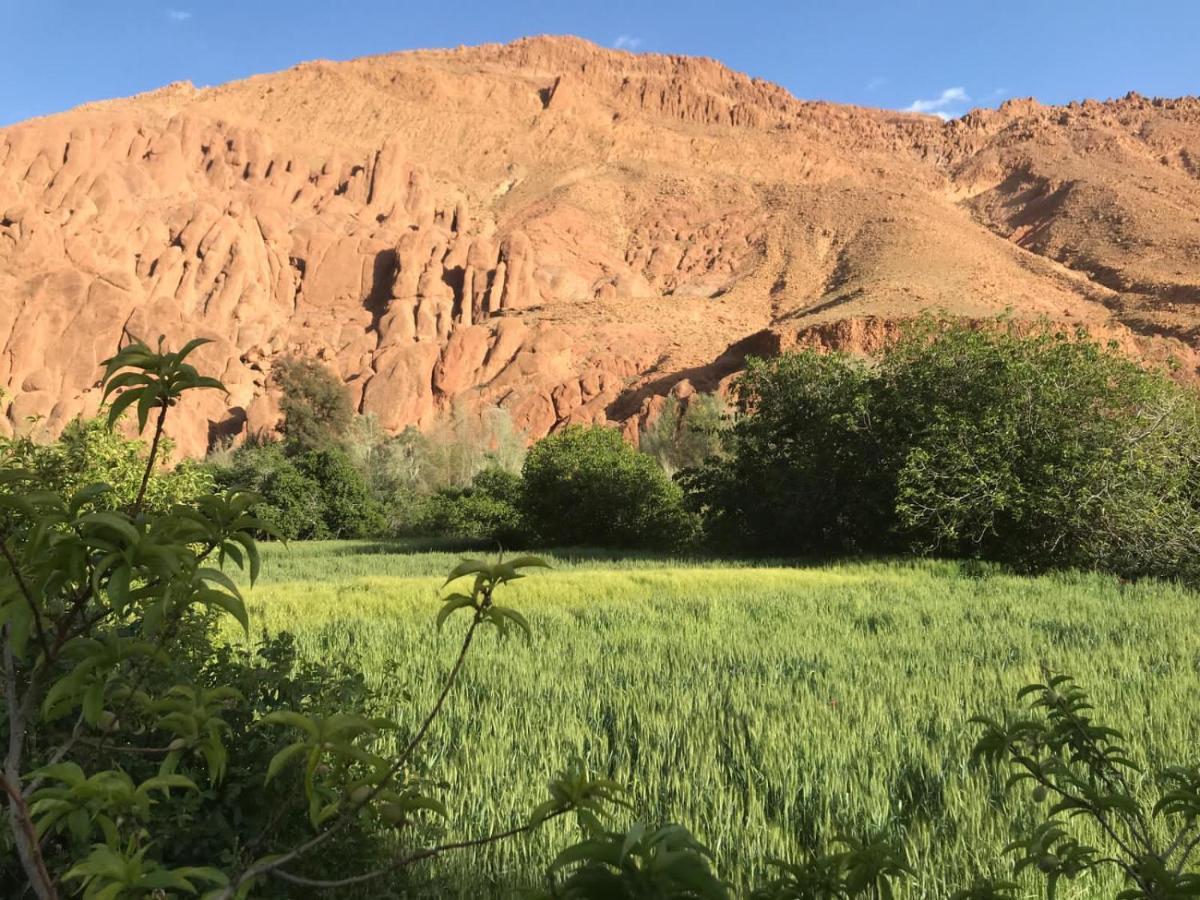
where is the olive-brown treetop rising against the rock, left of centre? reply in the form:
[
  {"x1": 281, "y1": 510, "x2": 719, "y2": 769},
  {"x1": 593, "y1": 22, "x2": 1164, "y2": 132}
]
[{"x1": 271, "y1": 358, "x2": 354, "y2": 450}]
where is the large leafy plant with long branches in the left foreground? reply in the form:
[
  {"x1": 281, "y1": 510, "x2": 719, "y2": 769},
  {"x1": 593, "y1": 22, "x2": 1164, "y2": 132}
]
[{"x1": 0, "y1": 341, "x2": 616, "y2": 900}]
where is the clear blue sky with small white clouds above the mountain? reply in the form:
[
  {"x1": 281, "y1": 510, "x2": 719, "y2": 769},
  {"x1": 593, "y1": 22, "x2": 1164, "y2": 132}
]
[{"x1": 0, "y1": 0, "x2": 1200, "y2": 125}]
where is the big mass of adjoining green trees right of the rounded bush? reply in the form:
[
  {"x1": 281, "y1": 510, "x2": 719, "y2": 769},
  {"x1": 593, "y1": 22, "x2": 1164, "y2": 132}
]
[{"x1": 685, "y1": 319, "x2": 1200, "y2": 576}]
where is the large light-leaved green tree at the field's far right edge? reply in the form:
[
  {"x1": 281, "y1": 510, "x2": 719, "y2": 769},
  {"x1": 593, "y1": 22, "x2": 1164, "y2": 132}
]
[{"x1": 875, "y1": 320, "x2": 1200, "y2": 576}]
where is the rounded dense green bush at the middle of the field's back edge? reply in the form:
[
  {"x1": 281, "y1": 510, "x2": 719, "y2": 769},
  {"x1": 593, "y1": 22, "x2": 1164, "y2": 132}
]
[{"x1": 522, "y1": 425, "x2": 690, "y2": 548}]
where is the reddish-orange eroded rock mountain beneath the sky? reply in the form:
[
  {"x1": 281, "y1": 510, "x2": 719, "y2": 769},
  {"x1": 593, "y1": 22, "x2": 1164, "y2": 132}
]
[{"x1": 0, "y1": 37, "x2": 1200, "y2": 452}]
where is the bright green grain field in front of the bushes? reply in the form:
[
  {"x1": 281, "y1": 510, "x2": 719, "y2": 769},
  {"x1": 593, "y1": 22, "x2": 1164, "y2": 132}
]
[{"x1": 226, "y1": 542, "x2": 1200, "y2": 898}]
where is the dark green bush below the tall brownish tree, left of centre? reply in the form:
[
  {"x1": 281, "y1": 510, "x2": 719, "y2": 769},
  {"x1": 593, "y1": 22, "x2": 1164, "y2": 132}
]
[{"x1": 216, "y1": 444, "x2": 384, "y2": 540}]
